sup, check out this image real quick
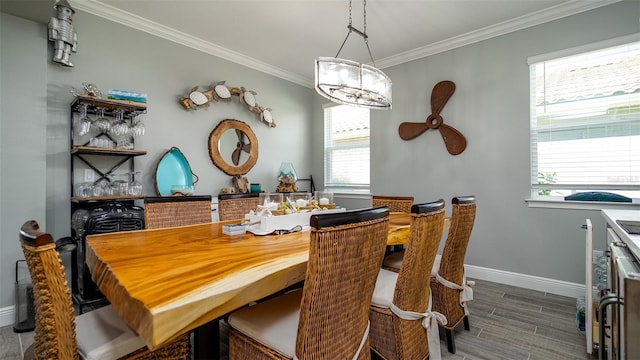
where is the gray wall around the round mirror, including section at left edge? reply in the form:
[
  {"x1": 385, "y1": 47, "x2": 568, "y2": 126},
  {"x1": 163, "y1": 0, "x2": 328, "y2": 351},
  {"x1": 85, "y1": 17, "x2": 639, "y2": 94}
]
[{"x1": 0, "y1": 12, "x2": 314, "y2": 308}]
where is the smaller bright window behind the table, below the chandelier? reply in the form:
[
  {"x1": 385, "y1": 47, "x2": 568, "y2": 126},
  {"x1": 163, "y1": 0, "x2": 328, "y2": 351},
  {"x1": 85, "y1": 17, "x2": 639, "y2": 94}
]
[{"x1": 324, "y1": 104, "x2": 369, "y2": 193}]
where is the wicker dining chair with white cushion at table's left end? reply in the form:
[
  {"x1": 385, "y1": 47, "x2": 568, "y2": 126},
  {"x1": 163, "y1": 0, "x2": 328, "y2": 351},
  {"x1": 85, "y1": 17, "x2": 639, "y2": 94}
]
[{"x1": 20, "y1": 220, "x2": 191, "y2": 360}]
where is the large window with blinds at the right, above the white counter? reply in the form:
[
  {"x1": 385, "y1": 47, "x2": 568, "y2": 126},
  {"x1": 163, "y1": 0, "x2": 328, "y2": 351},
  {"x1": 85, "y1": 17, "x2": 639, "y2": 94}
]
[{"x1": 529, "y1": 36, "x2": 640, "y2": 199}]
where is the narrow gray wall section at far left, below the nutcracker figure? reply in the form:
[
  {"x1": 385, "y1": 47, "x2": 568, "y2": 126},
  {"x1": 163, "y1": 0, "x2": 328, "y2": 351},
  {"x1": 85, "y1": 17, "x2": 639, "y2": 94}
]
[{"x1": 0, "y1": 14, "x2": 47, "y2": 308}]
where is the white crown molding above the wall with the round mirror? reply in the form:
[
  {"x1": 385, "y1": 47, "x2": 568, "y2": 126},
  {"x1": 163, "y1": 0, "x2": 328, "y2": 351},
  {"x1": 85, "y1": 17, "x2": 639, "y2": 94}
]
[{"x1": 69, "y1": 0, "x2": 313, "y2": 87}]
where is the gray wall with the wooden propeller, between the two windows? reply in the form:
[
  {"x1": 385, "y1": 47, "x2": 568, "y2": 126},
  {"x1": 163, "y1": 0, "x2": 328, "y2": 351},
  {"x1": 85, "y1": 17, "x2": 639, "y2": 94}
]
[{"x1": 313, "y1": 1, "x2": 640, "y2": 283}]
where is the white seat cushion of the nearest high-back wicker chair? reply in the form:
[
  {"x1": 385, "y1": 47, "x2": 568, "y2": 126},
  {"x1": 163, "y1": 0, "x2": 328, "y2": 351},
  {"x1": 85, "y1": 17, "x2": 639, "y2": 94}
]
[{"x1": 229, "y1": 290, "x2": 302, "y2": 358}]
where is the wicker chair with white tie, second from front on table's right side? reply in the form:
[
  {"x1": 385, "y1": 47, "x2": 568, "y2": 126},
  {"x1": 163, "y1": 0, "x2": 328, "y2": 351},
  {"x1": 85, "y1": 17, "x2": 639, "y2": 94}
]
[{"x1": 369, "y1": 200, "x2": 445, "y2": 360}]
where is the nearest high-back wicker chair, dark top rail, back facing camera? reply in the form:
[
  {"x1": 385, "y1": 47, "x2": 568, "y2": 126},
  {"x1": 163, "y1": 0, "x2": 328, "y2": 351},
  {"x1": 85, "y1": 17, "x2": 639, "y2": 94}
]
[{"x1": 229, "y1": 207, "x2": 389, "y2": 360}]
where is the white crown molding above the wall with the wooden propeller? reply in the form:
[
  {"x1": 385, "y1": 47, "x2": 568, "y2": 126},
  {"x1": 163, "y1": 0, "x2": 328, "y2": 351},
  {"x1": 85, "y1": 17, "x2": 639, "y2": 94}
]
[{"x1": 376, "y1": 0, "x2": 622, "y2": 69}]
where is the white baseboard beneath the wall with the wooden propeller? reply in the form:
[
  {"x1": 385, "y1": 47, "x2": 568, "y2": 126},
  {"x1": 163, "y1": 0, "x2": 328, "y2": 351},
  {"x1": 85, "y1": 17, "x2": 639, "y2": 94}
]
[{"x1": 465, "y1": 265, "x2": 585, "y2": 298}]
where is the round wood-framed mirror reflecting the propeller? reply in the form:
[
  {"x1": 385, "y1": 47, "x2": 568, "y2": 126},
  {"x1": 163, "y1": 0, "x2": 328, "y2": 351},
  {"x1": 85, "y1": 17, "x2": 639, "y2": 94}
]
[{"x1": 209, "y1": 119, "x2": 258, "y2": 175}]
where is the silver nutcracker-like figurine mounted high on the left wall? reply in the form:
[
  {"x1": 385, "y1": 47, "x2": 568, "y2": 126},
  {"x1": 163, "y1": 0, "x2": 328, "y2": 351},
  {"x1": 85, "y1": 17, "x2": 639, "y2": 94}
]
[{"x1": 49, "y1": 0, "x2": 78, "y2": 67}]
